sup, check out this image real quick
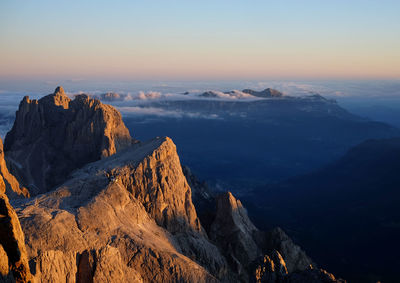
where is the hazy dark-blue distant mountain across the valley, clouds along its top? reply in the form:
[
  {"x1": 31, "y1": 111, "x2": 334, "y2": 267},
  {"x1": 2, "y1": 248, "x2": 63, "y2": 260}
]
[{"x1": 122, "y1": 89, "x2": 400, "y2": 193}]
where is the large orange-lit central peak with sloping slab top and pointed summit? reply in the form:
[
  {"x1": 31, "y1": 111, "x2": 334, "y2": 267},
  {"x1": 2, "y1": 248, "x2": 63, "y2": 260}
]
[{"x1": 19, "y1": 138, "x2": 229, "y2": 282}]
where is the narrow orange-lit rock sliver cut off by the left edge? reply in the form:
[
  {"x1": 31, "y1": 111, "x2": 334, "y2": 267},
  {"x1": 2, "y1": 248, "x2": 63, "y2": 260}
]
[{"x1": 0, "y1": 175, "x2": 32, "y2": 282}]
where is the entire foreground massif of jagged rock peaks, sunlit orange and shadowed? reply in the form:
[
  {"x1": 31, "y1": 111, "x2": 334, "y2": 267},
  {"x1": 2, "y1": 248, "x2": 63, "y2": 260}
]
[{"x1": 0, "y1": 89, "x2": 343, "y2": 283}]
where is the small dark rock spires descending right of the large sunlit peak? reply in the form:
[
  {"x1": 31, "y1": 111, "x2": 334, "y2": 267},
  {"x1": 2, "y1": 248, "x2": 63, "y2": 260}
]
[{"x1": 209, "y1": 192, "x2": 339, "y2": 283}]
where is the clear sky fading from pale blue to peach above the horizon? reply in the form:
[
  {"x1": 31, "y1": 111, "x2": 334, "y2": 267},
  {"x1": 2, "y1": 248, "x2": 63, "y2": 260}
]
[{"x1": 0, "y1": 0, "x2": 400, "y2": 81}]
